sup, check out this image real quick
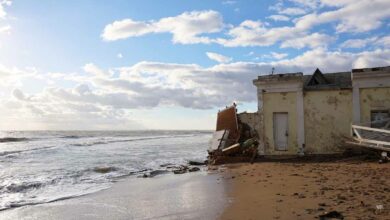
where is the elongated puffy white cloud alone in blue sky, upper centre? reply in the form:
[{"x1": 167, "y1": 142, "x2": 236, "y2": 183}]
[{"x1": 102, "y1": 10, "x2": 224, "y2": 44}]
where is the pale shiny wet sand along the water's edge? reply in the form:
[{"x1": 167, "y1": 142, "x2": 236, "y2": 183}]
[{"x1": 0, "y1": 172, "x2": 227, "y2": 220}]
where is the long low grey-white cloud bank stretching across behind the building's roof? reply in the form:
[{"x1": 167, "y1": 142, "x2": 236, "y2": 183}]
[{"x1": 0, "y1": 48, "x2": 390, "y2": 129}]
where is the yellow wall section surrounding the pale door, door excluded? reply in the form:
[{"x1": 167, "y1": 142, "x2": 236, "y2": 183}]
[{"x1": 263, "y1": 92, "x2": 298, "y2": 155}]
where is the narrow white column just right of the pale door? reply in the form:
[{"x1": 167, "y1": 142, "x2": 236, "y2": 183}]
[{"x1": 297, "y1": 89, "x2": 305, "y2": 155}]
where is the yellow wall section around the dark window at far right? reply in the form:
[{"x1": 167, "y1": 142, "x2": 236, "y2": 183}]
[{"x1": 360, "y1": 88, "x2": 390, "y2": 123}]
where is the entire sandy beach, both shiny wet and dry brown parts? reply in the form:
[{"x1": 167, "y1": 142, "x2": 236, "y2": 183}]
[{"x1": 0, "y1": 160, "x2": 390, "y2": 220}]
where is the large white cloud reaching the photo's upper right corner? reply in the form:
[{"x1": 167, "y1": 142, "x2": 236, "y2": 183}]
[{"x1": 217, "y1": 0, "x2": 390, "y2": 48}]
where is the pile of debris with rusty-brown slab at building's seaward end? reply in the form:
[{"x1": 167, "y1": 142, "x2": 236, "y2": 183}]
[{"x1": 208, "y1": 104, "x2": 259, "y2": 165}]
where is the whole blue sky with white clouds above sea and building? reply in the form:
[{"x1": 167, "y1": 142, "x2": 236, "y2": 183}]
[{"x1": 0, "y1": 0, "x2": 390, "y2": 130}]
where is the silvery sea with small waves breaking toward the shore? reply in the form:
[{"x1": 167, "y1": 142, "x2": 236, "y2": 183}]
[{"x1": 0, "y1": 131, "x2": 212, "y2": 210}]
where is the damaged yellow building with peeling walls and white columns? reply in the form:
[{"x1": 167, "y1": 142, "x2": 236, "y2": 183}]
[{"x1": 248, "y1": 67, "x2": 390, "y2": 155}]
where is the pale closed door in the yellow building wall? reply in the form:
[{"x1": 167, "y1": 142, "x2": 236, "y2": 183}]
[{"x1": 274, "y1": 113, "x2": 288, "y2": 150}]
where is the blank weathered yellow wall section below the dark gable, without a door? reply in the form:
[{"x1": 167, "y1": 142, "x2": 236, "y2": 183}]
[{"x1": 304, "y1": 90, "x2": 352, "y2": 154}]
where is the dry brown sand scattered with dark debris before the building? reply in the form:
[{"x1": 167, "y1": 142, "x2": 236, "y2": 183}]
[{"x1": 219, "y1": 161, "x2": 390, "y2": 219}]
